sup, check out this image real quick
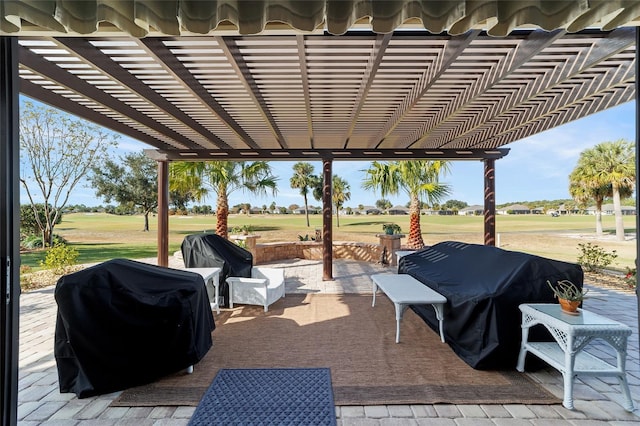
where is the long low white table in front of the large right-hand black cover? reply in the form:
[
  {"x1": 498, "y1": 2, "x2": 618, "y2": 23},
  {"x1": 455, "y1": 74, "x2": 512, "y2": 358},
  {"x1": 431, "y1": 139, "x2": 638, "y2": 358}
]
[{"x1": 371, "y1": 274, "x2": 447, "y2": 343}]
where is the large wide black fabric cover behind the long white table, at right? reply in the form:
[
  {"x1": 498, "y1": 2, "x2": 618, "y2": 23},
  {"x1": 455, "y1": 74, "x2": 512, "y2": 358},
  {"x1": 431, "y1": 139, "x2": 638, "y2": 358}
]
[{"x1": 398, "y1": 241, "x2": 583, "y2": 369}]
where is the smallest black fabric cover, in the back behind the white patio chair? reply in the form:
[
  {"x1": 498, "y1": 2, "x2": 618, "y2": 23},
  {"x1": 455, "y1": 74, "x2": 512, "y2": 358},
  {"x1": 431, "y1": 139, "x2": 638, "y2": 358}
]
[{"x1": 181, "y1": 233, "x2": 253, "y2": 308}]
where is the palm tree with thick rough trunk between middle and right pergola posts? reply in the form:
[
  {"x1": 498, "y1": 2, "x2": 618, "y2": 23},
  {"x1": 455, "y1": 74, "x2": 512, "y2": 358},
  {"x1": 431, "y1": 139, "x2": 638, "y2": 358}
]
[{"x1": 362, "y1": 160, "x2": 450, "y2": 249}]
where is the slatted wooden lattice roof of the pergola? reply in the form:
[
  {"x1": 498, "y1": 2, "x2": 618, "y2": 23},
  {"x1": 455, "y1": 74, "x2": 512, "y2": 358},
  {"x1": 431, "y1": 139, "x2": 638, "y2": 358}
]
[{"x1": 19, "y1": 27, "x2": 635, "y2": 160}]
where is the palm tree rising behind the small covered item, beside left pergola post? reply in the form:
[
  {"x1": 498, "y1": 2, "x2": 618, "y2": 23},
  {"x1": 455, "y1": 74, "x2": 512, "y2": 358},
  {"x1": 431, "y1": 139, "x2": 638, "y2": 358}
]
[{"x1": 169, "y1": 161, "x2": 278, "y2": 238}]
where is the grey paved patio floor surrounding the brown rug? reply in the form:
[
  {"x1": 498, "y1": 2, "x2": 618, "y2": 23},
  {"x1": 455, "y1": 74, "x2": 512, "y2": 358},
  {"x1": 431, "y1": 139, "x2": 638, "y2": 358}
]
[{"x1": 18, "y1": 257, "x2": 640, "y2": 425}]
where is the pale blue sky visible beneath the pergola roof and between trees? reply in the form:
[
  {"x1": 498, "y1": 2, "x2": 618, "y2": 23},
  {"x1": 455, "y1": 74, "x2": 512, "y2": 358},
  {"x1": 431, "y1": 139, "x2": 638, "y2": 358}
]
[{"x1": 23, "y1": 97, "x2": 635, "y2": 207}]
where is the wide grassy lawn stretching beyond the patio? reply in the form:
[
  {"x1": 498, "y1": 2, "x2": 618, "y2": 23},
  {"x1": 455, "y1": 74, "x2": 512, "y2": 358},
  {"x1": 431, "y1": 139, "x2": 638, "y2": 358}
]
[{"x1": 22, "y1": 213, "x2": 636, "y2": 269}]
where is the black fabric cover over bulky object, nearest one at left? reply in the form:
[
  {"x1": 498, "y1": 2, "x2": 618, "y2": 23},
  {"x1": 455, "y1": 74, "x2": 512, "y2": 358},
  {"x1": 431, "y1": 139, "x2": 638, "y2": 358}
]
[{"x1": 54, "y1": 259, "x2": 215, "y2": 398}]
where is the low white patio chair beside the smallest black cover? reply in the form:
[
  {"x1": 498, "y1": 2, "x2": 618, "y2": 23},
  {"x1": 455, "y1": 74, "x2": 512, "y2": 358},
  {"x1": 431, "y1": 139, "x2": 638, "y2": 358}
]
[{"x1": 226, "y1": 266, "x2": 284, "y2": 312}]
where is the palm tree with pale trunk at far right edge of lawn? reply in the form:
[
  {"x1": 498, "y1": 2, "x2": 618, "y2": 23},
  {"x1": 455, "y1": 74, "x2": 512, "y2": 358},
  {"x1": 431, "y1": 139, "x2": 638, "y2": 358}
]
[{"x1": 574, "y1": 139, "x2": 636, "y2": 241}]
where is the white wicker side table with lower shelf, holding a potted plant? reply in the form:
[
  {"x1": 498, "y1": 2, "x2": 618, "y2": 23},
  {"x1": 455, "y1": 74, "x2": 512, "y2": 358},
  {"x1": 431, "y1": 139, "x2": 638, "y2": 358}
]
[{"x1": 516, "y1": 303, "x2": 633, "y2": 411}]
